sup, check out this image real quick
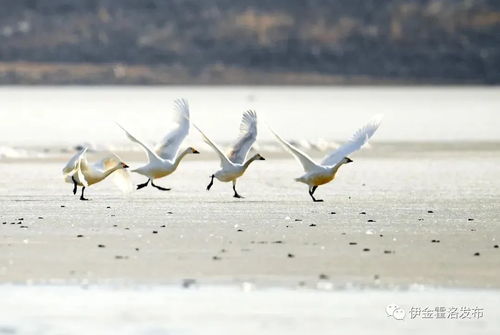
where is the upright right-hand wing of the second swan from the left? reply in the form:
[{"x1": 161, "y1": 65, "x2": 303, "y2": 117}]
[{"x1": 155, "y1": 99, "x2": 190, "y2": 160}]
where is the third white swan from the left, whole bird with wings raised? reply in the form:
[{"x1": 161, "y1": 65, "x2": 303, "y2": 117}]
[{"x1": 195, "y1": 111, "x2": 264, "y2": 198}]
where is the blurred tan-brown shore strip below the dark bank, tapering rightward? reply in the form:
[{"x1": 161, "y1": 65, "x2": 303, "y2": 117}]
[{"x1": 0, "y1": 62, "x2": 492, "y2": 86}]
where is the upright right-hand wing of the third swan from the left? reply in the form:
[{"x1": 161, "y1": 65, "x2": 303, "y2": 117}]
[{"x1": 228, "y1": 111, "x2": 257, "y2": 164}]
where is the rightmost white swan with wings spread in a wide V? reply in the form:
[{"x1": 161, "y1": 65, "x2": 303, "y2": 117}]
[{"x1": 271, "y1": 115, "x2": 382, "y2": 202}]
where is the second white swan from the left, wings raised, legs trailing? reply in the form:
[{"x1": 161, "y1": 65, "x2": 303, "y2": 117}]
[{"x1": 118, "y1": 99, "x2": 199, "y2": 191}]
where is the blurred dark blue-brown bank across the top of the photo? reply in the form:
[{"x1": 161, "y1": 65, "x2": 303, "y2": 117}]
[{"x1": 0, "y1": 0, "x2": 500, "y2": 85}]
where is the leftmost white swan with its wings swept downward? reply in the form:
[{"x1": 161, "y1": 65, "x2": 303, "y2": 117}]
[{"x1": 63, "y1": 148, "x2": 131, "y2": 200}]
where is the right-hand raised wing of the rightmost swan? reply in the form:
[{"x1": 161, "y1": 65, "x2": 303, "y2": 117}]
[{"x1": 321, "y1": 114, "x2": 383, "y2": 166}]
